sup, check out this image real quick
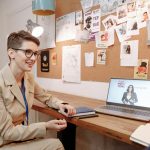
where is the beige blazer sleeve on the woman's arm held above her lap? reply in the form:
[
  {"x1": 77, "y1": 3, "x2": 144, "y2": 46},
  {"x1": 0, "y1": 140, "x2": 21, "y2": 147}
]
[{"x1": 0, "y1": 88, "x2": 46, "y2": 141}]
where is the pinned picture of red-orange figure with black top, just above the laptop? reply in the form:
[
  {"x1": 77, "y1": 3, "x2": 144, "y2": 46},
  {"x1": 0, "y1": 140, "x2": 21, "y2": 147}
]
[{"x1": 134, "y1": 59, "x2": 148, "y2": 79}]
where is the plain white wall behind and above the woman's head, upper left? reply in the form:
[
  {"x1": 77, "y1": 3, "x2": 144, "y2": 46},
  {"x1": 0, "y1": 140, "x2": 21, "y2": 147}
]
[{"x1": 0, "y1": 0, "x2": 32, "y2": 68}]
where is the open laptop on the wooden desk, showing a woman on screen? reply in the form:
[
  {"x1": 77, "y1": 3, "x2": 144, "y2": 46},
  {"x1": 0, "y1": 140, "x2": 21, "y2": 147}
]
[{"x1": 95, "y1": 78, "x2": 150, "y2": 121}]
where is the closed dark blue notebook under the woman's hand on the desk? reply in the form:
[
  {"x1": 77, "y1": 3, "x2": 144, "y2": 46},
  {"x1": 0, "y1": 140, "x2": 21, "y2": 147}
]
[{"x1": 59, "y1": 106, "x2": 96, "y2": 117}]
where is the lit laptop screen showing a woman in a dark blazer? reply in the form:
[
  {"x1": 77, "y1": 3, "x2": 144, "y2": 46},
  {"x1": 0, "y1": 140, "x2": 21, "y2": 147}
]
[{"x1": 107, "y1": 78, "x2": 150, "y2": 108}]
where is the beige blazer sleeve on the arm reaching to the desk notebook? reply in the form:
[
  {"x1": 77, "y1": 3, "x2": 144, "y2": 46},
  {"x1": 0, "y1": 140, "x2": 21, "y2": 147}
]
[{"x1": 34, "y1": 82, "x2": 63, "y2": 109}]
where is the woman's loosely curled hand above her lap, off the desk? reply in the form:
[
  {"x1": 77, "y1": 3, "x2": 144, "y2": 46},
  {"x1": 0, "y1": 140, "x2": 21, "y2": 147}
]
[{"x1": 46, "y1": 119, "x2": 67, "y2": 131}]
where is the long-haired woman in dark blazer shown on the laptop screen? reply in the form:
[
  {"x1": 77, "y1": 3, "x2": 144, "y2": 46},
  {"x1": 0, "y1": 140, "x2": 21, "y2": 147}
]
[{"x1": 122, "y1": 85, "x2": 138, "y2": 105}]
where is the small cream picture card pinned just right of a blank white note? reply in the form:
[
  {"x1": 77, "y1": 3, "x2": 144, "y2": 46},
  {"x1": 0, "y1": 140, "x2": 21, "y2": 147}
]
[{"x1": 97, "y1": 49, "x2": 106, "y2": 65}]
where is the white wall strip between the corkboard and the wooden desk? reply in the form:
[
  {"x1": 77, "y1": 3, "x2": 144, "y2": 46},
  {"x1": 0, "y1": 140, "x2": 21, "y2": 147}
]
[{"x1": 37, "y1": 78, "x2": 108, "y2": 100}]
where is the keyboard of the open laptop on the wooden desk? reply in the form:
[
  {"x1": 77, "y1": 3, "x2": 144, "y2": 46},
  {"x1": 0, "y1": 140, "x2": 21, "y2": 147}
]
[{"x1": 101, "y1": 105, "x2": 150, "y2": 116}]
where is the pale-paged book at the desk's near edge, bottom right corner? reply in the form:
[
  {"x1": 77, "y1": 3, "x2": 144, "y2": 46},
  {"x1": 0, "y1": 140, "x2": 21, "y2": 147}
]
[{"x1": 130, "y1": 123, "x2": 150, "y2": 147}]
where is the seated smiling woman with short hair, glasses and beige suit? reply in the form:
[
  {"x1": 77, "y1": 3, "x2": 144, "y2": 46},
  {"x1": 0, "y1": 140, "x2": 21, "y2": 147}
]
[{"x1": 0, "y1": 31, "x2": 75, "y2": 150}]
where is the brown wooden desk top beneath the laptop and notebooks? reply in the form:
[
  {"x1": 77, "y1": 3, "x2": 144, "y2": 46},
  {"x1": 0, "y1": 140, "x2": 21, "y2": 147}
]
[{"x1": 33, "y1": 92, "x2": 145, "y2": 146}]
